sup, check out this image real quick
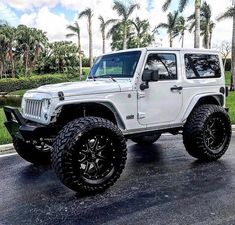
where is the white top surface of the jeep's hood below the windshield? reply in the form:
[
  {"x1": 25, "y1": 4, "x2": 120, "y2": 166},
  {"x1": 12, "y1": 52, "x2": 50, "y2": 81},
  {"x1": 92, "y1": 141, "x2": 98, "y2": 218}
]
[{"x1": 27, "y1": 80, "x2": 132, "y2": 97}]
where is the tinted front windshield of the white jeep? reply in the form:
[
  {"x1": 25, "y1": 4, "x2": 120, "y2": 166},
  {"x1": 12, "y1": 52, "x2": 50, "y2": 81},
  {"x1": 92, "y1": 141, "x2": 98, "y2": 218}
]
[{"x1": 88, "y1": 51, "x2": 141, "y2": 78}]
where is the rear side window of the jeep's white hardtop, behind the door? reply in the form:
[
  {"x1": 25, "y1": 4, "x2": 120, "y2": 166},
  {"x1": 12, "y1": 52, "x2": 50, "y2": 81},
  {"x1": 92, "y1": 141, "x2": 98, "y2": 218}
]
[{"x1": 184, "y1": 54, "x2": 221, "y2": 79}]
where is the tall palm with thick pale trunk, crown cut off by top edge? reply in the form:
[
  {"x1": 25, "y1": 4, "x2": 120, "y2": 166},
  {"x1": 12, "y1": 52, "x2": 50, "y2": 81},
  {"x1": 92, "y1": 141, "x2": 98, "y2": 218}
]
[{"x1": 162, "y1": 0, "x2": 201, "y2": 48}]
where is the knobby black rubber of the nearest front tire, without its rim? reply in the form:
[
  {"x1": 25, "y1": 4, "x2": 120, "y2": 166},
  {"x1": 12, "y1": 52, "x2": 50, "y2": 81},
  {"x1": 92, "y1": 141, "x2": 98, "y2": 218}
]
[{"x1": 52, "y1": 117, "x2": 127, "y2": 193}]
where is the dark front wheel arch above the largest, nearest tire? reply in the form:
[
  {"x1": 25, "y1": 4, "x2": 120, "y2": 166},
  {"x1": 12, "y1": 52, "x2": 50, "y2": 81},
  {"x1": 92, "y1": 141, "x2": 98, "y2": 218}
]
[{"x1": 53, "y1": 101, "x2": 125, "y2": 129}]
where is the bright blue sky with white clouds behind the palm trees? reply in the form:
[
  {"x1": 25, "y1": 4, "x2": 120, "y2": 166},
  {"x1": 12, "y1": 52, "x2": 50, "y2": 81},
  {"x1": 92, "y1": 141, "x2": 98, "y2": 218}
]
[{"x1": 0, "y1": 0, "x2": 232, "y2": 56}]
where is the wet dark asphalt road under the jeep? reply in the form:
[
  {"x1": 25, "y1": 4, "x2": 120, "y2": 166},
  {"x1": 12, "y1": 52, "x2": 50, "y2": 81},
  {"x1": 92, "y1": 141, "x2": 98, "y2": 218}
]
[{"x1": 0, "y1": 136, "x2": 235, "y2": 225}]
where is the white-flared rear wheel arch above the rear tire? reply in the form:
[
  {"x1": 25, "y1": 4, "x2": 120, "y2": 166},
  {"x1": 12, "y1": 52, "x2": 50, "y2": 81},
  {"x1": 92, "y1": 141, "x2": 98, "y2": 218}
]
[{"x1": 183, "y1": 94, "x2": 225, "y2": 122}]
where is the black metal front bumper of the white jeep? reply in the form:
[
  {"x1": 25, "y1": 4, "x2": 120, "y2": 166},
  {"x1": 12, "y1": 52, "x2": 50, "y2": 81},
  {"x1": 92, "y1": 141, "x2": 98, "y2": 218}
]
[{"x1": 4, "y1": 106, "x2": 49, "y2": 140}]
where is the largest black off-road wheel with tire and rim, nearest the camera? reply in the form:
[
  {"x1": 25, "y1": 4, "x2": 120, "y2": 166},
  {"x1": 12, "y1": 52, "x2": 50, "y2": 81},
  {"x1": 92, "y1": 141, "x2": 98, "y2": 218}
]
[{"x1": 52, "y1": 117, "x2": 127, "y2": 194}]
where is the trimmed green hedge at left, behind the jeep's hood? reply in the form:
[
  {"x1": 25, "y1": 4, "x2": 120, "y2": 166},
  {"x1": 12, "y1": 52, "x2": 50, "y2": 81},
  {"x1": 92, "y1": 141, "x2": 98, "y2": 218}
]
[{"x1": 0, "y1": 74, "x2": 69, "y2": 92}]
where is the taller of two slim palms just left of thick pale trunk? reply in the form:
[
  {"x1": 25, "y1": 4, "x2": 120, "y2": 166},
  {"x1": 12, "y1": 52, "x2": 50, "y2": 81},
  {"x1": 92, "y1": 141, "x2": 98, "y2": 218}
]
[{"x1": 157, "y1": 11, "x2": 179, "y2": 47}]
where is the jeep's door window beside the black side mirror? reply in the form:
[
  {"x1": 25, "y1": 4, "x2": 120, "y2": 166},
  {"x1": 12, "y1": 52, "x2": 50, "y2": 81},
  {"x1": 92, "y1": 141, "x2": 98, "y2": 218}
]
[{"x1": 144, "y1": 53, "x2": 177, "y2": 80}]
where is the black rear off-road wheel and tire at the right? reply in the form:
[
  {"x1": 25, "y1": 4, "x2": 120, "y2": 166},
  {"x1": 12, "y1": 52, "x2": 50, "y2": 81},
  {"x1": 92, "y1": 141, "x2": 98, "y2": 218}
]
[{"x1": 183, "y1": 104, "x2": 231, "y2": 161}]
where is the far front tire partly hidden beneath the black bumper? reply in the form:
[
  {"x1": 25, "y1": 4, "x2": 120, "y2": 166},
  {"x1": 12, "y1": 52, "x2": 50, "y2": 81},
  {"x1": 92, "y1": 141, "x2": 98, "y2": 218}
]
[{"x1": 13, "y1": 138, "x2": 51, "y2": 165}]
